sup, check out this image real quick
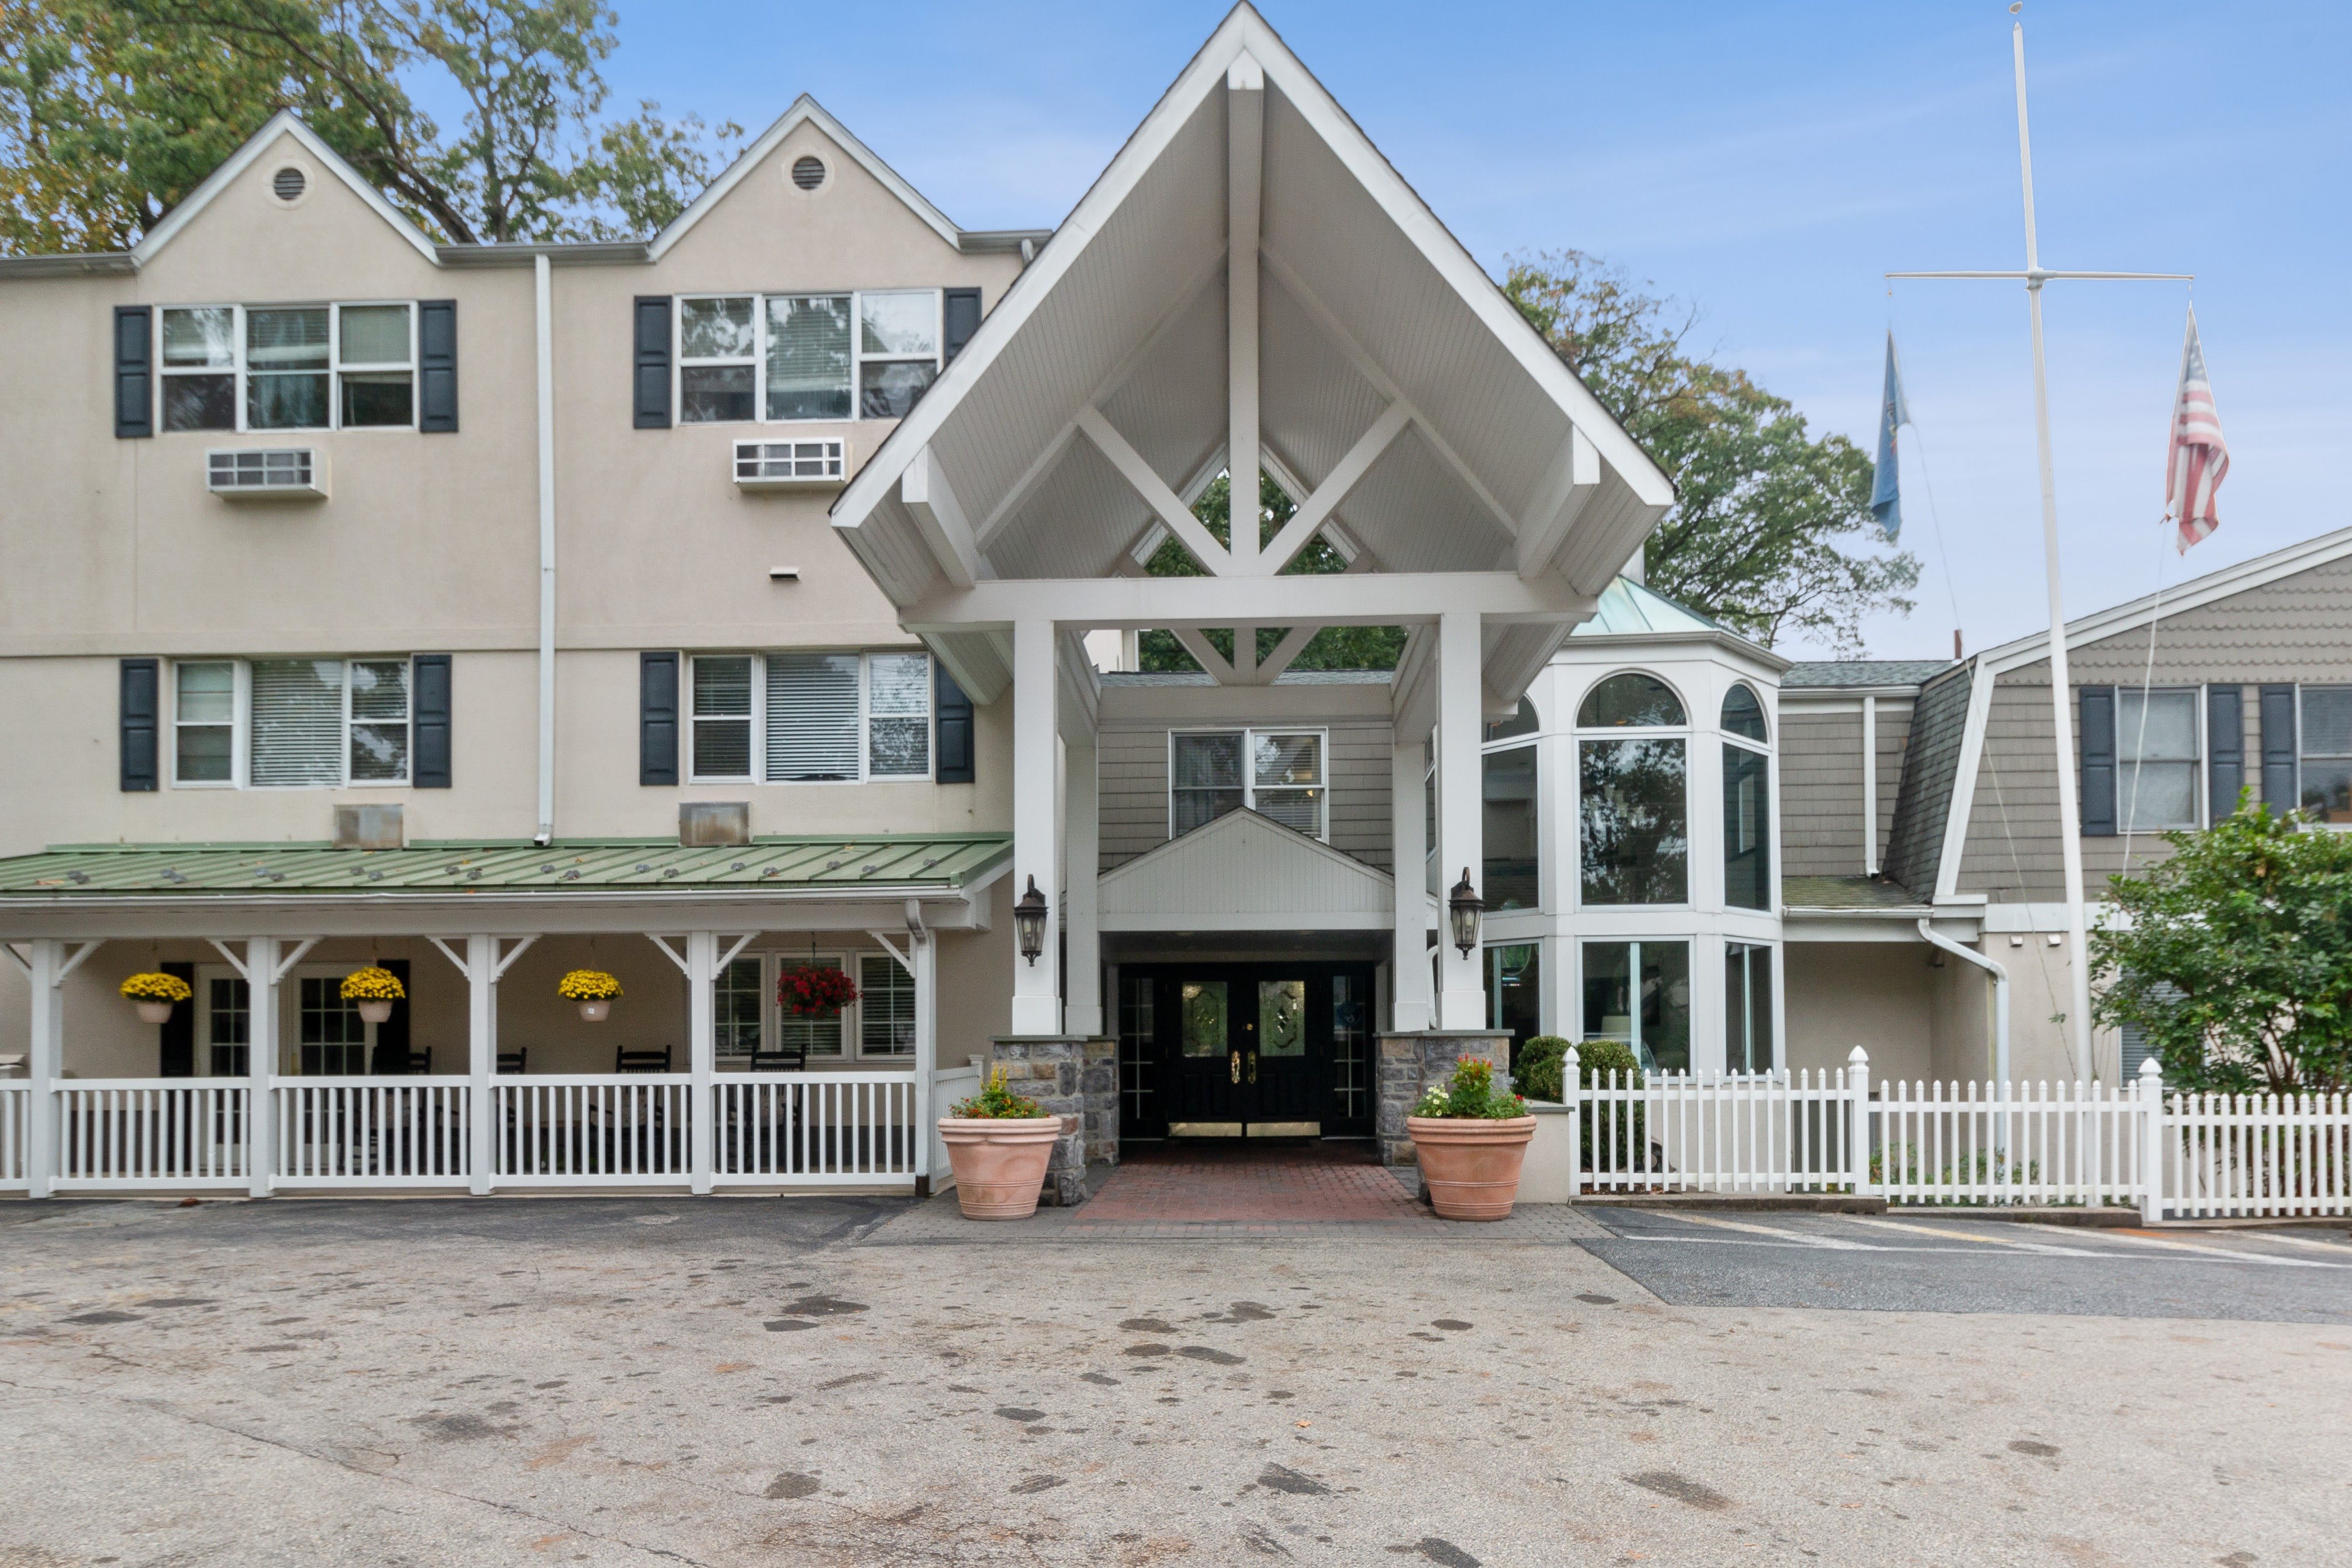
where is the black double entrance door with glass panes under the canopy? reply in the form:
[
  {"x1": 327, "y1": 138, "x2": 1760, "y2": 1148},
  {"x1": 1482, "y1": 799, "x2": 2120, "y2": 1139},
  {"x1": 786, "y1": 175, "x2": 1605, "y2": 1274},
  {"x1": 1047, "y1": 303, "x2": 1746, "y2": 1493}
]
[{"x1": 1122, "y1": 964, "x2": 1374, "y2": 1138}]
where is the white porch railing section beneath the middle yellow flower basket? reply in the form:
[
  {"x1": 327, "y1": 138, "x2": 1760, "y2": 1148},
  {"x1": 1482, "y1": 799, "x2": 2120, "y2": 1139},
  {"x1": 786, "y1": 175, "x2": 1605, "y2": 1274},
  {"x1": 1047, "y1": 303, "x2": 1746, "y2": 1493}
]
[{"x1": 273, "y1": 1077, "x2": 470, "y2": 1187}]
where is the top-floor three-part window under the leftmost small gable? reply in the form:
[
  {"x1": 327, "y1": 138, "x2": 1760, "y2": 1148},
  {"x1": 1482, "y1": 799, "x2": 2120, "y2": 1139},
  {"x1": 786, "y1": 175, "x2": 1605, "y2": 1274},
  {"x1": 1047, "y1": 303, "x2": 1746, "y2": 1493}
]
[{"x1": 158, "y1": 301, "x2": 417, "y2": 430}]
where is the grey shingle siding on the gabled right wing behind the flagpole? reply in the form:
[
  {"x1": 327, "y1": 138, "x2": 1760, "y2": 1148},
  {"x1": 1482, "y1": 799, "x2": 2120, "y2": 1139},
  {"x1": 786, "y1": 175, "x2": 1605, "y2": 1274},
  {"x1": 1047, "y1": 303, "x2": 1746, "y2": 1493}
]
[{"x1": 1959, "y1": 562, "x2": 2352, "y2": 901}]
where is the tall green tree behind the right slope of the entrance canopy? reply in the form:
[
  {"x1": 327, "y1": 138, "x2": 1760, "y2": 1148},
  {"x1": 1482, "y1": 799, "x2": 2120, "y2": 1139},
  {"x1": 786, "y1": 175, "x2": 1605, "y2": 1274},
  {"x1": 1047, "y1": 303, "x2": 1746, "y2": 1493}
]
[{"x1": 1503, "y1": 251, "x2": 1919, "y2": 651}]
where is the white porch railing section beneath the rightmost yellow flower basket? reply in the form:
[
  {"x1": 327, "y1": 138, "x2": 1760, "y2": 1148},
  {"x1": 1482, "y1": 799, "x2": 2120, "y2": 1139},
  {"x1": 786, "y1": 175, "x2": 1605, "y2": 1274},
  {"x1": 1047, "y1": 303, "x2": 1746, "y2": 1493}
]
[{"x1": 489, "y1": 1072, "x2": 694, "y2": 1187}]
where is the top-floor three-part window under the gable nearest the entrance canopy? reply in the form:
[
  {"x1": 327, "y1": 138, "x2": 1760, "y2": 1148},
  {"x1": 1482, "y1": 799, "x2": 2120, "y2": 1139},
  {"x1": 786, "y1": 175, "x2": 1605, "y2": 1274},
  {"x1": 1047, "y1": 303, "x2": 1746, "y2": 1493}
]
[{"x1": 677, "y1": 289, "x2": 943, "y2": 426}]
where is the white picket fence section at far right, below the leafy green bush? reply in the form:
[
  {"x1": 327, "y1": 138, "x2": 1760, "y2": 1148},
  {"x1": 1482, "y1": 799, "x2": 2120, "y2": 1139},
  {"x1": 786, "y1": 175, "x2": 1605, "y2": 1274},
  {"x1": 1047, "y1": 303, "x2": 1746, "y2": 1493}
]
[{"x1": 2157, "y1": 1095, "x2": 2352, "y2": 1220}]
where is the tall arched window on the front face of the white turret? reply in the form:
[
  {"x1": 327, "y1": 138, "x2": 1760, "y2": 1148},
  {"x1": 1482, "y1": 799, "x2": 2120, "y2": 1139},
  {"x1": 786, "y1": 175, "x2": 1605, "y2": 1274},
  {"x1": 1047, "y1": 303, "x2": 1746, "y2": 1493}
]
[{"x1": 1576, "y1": 670, "x2": 1691, "y2": 905}]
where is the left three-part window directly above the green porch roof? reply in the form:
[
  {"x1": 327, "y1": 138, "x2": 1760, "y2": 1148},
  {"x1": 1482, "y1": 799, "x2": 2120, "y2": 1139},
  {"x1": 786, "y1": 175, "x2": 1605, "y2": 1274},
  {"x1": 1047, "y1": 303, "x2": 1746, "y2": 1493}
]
[{"x1": 171, "y1": 658, "x2": 411, "y2": 790}]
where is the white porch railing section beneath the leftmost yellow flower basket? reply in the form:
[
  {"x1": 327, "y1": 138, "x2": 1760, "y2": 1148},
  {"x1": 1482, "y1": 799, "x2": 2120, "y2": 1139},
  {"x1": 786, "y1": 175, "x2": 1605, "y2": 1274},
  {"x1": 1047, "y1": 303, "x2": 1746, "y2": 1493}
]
[{"x1": 52, "y1": 1079, "x2": 249, "y2": 1192}]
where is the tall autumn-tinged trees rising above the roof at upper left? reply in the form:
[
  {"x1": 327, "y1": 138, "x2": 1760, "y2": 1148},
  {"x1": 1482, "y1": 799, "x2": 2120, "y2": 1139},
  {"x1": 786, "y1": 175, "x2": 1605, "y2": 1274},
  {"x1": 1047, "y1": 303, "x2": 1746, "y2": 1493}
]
[{"x1": 0, "y1": 0, "x2": 741, "y2": 251}]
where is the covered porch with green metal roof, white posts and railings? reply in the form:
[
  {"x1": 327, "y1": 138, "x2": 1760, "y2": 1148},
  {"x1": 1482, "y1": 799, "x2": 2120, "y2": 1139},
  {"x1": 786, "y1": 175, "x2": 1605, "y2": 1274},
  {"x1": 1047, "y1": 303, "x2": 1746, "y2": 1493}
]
[{"x1": 0, "y1": 834, "x2": 1009, "y2": 1197}]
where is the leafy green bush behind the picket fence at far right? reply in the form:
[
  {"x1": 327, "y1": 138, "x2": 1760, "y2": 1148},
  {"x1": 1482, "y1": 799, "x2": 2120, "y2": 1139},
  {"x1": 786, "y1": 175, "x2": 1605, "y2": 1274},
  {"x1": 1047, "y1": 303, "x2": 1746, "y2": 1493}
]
[{"x1": 2091, "y1": 804, "x2": 2352, "y2": 1093}]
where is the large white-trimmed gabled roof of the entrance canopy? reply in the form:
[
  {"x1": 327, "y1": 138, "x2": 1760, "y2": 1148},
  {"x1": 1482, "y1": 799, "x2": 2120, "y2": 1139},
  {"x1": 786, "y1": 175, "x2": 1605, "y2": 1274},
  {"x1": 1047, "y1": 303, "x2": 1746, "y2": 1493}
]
[{"x1": 833, "y1": 5, "x2": 1672, "y2": 634}]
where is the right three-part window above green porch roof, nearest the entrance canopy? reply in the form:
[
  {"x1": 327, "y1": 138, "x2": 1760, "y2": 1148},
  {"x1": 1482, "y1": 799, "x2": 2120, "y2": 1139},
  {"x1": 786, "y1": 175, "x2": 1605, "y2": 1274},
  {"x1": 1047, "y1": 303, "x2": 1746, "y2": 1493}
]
[{"x1": 687, "y1": 651, "x2": 931, "y2": 783}]
